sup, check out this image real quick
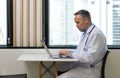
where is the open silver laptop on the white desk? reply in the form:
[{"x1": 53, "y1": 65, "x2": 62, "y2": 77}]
[{"x1": 41, "y1": 40, "x2": 73, "y2": 59}]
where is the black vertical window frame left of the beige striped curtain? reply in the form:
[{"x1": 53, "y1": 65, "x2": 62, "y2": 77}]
[{"x1": 7, "y1": 0, "x2": 13, "y2": 47}]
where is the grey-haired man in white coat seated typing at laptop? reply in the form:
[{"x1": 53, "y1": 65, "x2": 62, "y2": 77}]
[{"x1": 58, "y1": 10, "x2": 107, "y2": 78}]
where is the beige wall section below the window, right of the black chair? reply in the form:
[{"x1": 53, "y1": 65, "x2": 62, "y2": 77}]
[{"x1": 105, "y1": 50, "x2": 120, "y2": 78}]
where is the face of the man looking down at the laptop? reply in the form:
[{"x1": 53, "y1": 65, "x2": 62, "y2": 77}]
[{"x1": 74, "y1": 14, "x2": 88, "y2": 32}]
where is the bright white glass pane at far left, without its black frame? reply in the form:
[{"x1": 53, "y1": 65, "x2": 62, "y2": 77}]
[{"x1": 0, "y1": 0, "x2": 7, "y2": 45}]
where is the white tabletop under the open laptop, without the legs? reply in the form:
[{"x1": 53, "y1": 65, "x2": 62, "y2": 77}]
[{"x1": 17, "y1": 54, "x2": 78, "y2": 62}]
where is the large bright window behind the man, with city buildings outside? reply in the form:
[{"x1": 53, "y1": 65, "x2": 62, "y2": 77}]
[{"x1": 44, "y1": 0, "x2": 120, "y2": 47}]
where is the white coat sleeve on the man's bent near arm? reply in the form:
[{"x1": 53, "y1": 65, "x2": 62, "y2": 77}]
[{"x1": 73, "y1": 33, "x2": 106, "y2": 64}]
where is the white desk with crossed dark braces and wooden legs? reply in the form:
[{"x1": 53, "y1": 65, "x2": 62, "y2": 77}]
[{"x1": 17, "y1": 54, "x2": 78, "y2": 78}]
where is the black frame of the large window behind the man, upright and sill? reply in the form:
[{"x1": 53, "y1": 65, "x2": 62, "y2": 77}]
[{"x1": 43, "y1": 0, "x2": 120, "y2": 49}]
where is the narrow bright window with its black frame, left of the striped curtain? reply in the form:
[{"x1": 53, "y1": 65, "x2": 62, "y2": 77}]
[{"x1": 0, "y1": 0, "x2": 12, "y2": 46}]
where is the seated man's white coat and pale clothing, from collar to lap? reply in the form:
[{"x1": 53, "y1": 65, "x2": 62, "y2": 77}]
[{"x1": 58, "y1": 24, "x2": 107, "y2": 78}]
